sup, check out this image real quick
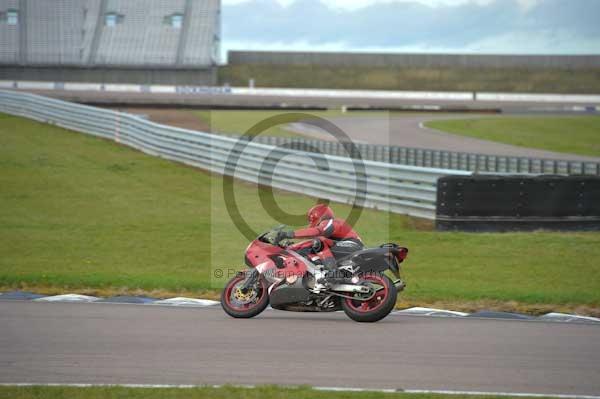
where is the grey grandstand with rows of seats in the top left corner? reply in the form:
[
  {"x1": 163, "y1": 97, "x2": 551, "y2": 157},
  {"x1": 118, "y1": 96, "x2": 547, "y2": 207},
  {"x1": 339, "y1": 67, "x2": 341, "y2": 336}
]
[{"x1": 0, "y1": 0, "x2": 220, "y2": 84}]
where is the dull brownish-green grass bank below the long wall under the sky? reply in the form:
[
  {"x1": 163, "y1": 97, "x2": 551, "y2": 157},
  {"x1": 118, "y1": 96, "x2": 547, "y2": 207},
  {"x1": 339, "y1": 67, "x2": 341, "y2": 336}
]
[{"x1": 219, "y1": 64, "x2": 600, "y2": 94}]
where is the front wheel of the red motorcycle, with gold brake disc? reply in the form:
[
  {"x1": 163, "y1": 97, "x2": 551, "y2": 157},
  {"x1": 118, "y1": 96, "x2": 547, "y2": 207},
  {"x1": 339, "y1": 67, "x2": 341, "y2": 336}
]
[{"x1": 221, "y1": 274, "x2": 269, "y2": 319}]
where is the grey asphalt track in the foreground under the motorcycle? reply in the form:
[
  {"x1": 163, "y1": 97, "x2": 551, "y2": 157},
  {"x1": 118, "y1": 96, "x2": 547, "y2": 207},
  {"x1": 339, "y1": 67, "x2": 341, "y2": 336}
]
[{"x1": 0, "y1": 301, "x2": 600, "y2": 395}]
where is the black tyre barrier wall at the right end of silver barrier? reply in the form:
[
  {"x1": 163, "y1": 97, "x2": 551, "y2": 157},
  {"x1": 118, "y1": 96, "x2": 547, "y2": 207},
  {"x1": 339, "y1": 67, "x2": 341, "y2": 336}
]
[{"x1": 436, "y1": 175, "x2": 600, "y2": 232}]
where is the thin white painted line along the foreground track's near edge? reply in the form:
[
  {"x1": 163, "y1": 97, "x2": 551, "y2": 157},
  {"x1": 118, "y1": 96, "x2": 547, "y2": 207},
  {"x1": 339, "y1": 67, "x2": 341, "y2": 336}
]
[{"x1": 0, "y1": 382, "x2": 600, "y2": 399}]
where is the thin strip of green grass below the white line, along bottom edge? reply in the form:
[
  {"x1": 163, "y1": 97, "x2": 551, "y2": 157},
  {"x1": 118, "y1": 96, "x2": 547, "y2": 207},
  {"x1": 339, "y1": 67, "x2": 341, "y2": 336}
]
[{"x1": 0, "y1": 386, "x2": 564, "y2": 399}]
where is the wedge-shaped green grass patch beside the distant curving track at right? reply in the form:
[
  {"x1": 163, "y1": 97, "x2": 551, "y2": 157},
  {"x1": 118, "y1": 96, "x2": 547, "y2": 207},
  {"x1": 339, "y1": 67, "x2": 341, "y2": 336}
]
[{"x1": 426, "y1": 116, "x2": 600, "y2": 157}]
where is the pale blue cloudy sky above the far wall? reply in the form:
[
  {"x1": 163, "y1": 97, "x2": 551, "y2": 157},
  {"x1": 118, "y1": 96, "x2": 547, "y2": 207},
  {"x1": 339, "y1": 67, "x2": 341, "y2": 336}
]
[{"x1": 222, "y1": 0, "x2": 600, "y2": 60}]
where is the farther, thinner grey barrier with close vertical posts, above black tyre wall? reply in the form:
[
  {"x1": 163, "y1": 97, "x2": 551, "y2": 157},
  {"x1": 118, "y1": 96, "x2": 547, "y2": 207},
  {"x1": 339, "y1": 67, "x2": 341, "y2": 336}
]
[{"x1": 248, "y1": 136, "x2": 600, "y2": 176}]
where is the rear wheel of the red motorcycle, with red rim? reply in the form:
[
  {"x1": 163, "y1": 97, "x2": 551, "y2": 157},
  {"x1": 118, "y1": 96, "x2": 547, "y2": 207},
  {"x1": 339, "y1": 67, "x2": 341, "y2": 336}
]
[{"x1": 342, "y1": 274, "x2": 398, "y2": 323}]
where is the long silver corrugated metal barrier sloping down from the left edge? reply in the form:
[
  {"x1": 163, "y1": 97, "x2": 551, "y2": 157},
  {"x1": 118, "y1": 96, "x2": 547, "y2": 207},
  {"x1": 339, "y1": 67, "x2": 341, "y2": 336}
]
[{"x1": 0, "y1": 90, "x2": 470, "y2": 219}]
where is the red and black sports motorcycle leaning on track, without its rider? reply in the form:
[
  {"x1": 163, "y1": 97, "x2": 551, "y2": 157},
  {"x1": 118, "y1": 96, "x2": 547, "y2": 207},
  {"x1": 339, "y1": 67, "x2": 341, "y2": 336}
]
[{"x1": 221, "y1": 229, "x2": 408, "y2": 322}]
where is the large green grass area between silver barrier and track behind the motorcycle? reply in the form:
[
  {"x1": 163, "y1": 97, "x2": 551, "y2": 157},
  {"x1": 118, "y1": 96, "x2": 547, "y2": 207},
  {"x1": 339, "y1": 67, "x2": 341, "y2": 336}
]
[{"x1": 0, "y1": 114, "x2": 600, "y2": 307}]
